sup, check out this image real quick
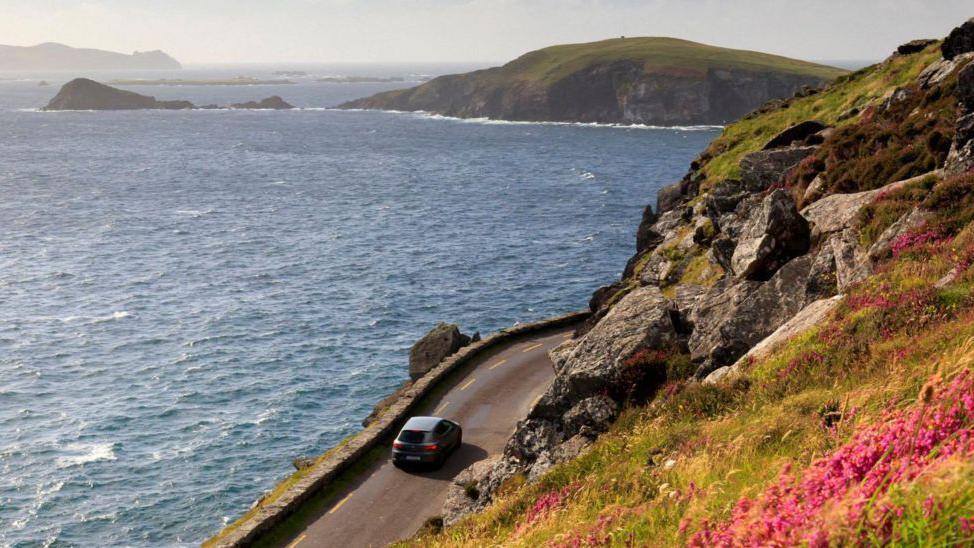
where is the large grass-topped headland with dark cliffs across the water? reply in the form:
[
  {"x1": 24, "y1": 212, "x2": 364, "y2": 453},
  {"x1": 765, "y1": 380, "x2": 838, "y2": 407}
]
[{"x1": 341, "y1": 38, "x2": 844, "y2": 125}]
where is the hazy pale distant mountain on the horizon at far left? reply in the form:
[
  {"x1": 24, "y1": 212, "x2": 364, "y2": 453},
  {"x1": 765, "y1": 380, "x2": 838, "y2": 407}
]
[{"x1": 0, "y1": 42, "x2": 183, "y2": 70}]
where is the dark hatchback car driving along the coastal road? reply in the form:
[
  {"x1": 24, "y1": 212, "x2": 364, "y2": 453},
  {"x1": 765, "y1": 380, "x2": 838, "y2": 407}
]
[{"x1": 392, "y1": 417, "x2": 463, "y2": 467}]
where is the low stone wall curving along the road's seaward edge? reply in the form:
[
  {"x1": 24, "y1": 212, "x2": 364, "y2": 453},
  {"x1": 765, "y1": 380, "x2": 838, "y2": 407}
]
[{"x1": 208, "y1": 312, "x2": 589, "y2": 547}]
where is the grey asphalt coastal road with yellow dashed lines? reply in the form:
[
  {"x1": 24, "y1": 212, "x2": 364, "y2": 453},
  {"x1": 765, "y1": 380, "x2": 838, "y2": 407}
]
[{"x1": 268, "y1": 328, "x2": 572, "y2": 548}]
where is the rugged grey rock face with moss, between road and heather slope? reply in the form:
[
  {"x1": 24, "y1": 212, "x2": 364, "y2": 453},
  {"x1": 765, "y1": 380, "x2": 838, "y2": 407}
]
[{"x1": 444, "y1": 27, "x2": 974, "y2": 520}]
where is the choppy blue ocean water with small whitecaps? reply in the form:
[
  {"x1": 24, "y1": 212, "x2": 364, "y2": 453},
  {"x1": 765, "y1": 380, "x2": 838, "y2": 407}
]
[{"x1": 0, "y1": 67, "x2": 717, "y2": 546}]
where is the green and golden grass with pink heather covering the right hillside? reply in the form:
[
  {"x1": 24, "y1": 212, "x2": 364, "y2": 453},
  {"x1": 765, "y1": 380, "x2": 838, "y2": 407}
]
[{"x1": 410, "y1": 44, "x2": 974, "y2": 546}]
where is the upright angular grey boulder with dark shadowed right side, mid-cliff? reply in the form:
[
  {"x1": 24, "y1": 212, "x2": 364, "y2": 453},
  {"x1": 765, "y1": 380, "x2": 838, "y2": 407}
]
[{"x1": 731, "y1": 189, "x2": 809, "y2": 279}]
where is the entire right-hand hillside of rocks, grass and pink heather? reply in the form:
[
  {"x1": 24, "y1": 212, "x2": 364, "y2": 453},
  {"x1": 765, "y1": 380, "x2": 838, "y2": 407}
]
[{"x1": 421, "y1": 20, "x2": 974, "y2": 546}]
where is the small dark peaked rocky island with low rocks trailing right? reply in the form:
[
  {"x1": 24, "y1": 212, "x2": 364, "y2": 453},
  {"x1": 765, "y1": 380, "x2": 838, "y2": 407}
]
[{"x1": 43, "y1": 78, "x2": 294, "y2": 110}]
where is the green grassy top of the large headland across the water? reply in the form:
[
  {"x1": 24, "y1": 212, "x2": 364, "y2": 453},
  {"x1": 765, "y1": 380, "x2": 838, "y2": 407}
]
[{"x1": 350, "y1": 37, "x2": 847, "y2": 105}]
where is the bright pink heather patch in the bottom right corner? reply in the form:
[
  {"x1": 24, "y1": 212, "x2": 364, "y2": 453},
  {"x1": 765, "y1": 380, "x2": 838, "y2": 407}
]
[{"x1": 688, "y1": 371, "x2": 974, "y2": 547}]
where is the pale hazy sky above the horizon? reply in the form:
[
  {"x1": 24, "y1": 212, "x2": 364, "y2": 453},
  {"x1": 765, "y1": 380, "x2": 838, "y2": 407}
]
[{"x1": 0, "y1": 0, "x2": 974, "y2": 64}]
